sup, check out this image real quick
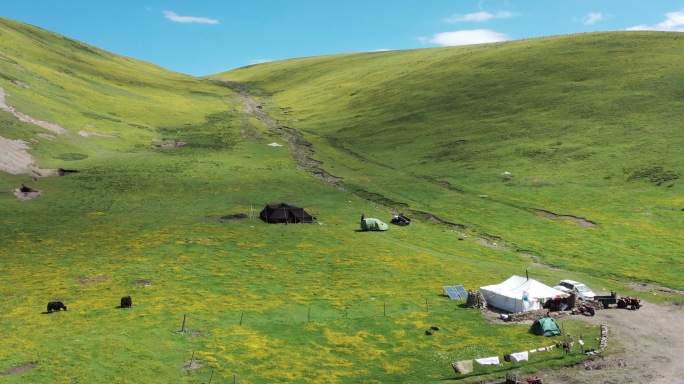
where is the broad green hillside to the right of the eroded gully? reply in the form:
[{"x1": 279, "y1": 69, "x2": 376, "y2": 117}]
[{"x1": 217, "y1": 32, "x2": 684, "y2": 290}]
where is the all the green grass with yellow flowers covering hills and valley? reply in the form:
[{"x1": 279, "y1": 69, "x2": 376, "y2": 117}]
[{"x1": 0, "y1": 19, "x2": 684, "y2": 383}]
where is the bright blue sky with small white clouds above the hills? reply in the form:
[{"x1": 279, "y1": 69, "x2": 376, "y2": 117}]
[{"x1": 0, "y1": 0, "x2": 684, "y2": 76}]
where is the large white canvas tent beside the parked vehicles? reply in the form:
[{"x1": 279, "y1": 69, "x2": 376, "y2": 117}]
[{"x1": 480, "y1": 276, "x2": 568, "y2": 313}]
